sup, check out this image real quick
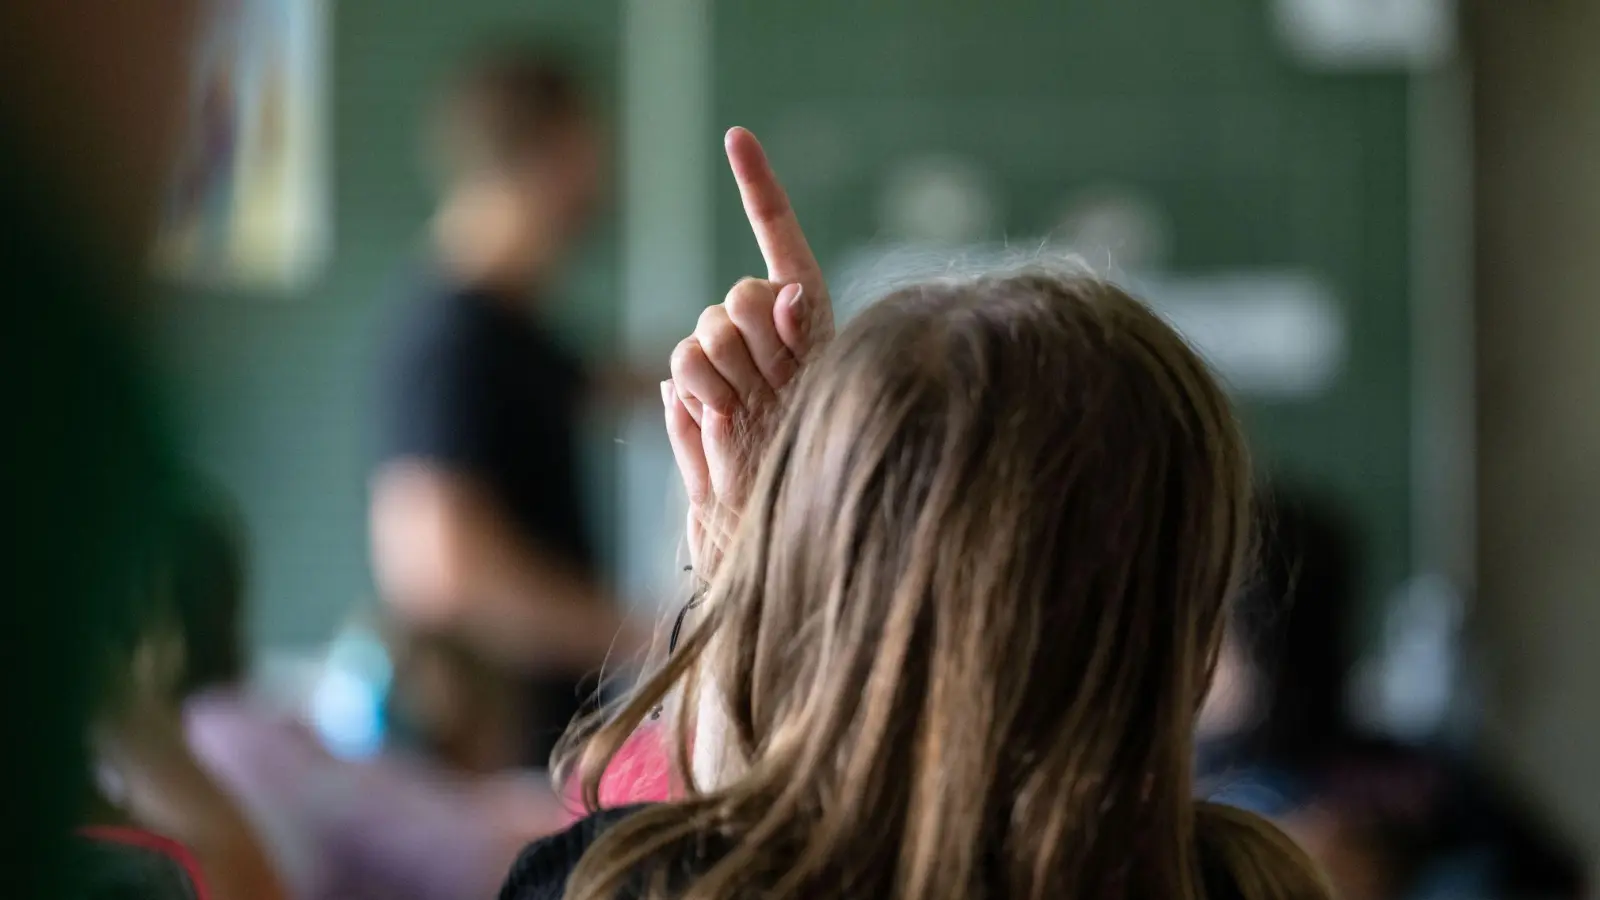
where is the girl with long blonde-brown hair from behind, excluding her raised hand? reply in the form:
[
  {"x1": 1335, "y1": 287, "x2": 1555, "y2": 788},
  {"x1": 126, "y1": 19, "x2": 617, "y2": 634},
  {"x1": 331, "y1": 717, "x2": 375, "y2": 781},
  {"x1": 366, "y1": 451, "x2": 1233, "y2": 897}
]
[{"x1": 563, "y1": 269, "x2": 1326, "y2": 900}]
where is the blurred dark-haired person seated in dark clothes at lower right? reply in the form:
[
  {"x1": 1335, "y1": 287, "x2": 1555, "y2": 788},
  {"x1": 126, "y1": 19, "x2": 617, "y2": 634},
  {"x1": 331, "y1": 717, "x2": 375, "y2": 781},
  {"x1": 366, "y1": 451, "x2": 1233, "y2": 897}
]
[{"x1": 1200, "y1": 487, "x2": 1582, "y2": 900}]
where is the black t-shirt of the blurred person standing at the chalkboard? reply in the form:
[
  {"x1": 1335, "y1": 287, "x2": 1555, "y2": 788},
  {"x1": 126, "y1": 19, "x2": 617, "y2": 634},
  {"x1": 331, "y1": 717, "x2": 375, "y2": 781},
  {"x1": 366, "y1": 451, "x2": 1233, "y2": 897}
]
[{"x1": 379, "y1": 278, "x2": 595, "y2": 755}]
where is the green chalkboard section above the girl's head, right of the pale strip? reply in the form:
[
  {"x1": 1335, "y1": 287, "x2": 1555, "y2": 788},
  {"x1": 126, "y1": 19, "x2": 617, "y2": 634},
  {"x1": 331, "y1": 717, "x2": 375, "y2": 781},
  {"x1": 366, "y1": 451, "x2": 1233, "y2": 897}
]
[{"x1": 714, "y1": 0, "x2": 1410, "y2": 605}]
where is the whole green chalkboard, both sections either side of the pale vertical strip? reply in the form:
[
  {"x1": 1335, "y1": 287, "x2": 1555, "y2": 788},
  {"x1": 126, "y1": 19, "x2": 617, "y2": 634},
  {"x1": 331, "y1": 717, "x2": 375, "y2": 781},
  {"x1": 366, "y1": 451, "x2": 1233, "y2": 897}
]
[{"x1": 162, "y1": 0, "x2": 1411, "y2": 645}]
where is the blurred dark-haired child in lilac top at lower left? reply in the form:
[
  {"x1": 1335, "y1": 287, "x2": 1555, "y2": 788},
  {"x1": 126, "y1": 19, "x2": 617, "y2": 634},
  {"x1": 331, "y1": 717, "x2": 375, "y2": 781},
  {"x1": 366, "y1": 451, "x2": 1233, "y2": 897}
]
[{"x1": 147, "y1": 487, "x2": 565, "y2": 900}]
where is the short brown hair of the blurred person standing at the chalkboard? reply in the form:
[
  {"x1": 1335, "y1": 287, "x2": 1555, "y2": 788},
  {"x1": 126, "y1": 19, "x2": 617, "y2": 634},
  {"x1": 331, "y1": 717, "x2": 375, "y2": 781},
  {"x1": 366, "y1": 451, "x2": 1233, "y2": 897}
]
[{"x1": 435, "y1": 43, "x2": 589, "y2": 178}]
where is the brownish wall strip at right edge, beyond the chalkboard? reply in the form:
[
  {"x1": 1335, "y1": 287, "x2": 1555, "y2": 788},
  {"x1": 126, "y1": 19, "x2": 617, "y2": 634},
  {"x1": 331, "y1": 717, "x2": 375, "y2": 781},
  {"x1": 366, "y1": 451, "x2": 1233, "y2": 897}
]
[{"x1": 1472, "y1": 0, "x2": 1600, "y2": 874}]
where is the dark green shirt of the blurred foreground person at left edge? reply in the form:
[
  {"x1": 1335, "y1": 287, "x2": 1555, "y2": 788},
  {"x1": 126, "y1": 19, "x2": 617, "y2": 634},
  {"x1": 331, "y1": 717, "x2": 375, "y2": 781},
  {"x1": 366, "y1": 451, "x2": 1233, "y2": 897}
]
[{"x1": 0, "y1": 131, "x2": 173, "y2": 897}]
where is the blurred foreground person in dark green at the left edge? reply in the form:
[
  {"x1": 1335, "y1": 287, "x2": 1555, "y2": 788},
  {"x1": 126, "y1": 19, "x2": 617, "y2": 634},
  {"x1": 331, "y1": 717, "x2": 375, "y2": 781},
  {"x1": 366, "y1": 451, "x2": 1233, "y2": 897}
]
[{"x1": 0, "y1": 0, "x2": 217, "y2": 900}]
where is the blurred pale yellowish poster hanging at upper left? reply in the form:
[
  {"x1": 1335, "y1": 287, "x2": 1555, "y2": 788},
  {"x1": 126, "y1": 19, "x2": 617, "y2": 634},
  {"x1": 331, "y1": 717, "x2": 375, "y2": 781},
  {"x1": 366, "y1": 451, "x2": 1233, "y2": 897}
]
[{"x1": 157, "y1": 0, "x2": 330, "y2": 288}]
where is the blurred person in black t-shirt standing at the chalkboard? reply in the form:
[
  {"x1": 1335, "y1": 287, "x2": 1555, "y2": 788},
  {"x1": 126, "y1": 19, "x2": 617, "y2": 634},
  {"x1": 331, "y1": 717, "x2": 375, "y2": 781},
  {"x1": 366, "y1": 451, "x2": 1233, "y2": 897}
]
[{"x1": 371, "y1": 45, "x2": 643, "y2": 772}]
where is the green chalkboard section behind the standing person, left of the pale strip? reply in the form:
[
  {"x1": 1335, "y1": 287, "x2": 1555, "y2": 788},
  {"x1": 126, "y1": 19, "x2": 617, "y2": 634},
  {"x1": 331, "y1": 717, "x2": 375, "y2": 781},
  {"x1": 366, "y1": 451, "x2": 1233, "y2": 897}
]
[{"x1": 160, "y1": 0, "x2": 619, "y2": 645}]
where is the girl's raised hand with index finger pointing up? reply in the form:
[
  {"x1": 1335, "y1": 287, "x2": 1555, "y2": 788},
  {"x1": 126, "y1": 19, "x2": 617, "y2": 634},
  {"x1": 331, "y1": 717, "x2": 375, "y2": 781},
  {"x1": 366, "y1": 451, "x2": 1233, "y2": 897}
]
[{"x1": 661, "y1": 128, "x2": 834, "y2": 565}]
